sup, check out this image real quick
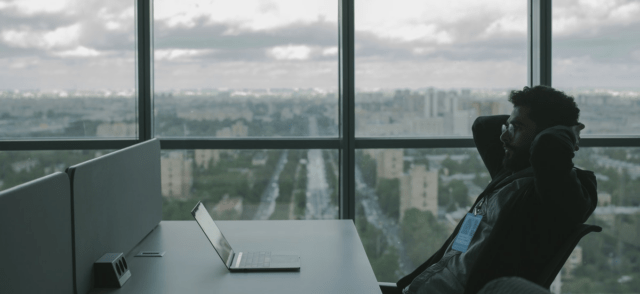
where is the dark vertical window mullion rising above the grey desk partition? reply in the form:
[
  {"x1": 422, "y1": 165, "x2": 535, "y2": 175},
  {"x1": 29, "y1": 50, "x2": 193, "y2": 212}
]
[{"x1": 136, "y1": 0, "x2": 153, "y2": 141}]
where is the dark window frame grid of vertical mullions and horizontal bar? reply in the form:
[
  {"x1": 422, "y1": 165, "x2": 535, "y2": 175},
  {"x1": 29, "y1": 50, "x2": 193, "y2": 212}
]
[{"x1": 0, "y1": 0, "x2": 640, "y2": 222}]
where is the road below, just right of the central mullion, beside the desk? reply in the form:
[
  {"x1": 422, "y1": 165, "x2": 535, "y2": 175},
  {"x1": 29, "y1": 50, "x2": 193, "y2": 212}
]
[{"x1": 356, "y1": 165, "x2": 414, "y2": 276}]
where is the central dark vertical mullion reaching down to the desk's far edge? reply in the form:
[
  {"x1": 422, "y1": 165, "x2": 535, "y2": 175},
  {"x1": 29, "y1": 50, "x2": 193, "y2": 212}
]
[{"x1": 338, "y1": 0, "x2": 356, "y2": 221}]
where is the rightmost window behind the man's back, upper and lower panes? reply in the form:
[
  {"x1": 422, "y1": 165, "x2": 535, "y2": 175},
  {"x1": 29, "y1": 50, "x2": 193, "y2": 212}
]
[{"x1": 551, "y1": 0, "x2": 640, "y2": 293}]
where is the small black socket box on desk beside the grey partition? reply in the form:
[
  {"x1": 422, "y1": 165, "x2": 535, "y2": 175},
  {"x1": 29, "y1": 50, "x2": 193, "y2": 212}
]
[{"x1": 93, "y1": 253, "x2": 131, "y2": 288}]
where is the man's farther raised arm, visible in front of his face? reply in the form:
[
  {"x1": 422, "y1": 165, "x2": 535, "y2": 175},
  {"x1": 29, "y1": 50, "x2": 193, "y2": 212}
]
[{"x1": 471, "y1": 115, "x2": 509, "y2": 179}]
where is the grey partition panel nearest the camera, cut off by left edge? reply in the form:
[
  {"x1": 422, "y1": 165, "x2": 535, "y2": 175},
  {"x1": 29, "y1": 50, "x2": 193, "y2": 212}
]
[{"x1": 0, "y1": 173, "x2": 73, "y2": 293}]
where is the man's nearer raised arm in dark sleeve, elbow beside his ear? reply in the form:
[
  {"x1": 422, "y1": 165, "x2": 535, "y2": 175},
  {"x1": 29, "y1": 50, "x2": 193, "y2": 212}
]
[{"x1": 530, "y1": 126, "x2": 596, "y2": 222}]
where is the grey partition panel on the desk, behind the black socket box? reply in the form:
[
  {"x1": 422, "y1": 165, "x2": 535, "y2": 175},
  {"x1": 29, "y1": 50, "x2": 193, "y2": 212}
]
[{"x1": 67, "y1": 139, "x2": 162, "y2": 293}]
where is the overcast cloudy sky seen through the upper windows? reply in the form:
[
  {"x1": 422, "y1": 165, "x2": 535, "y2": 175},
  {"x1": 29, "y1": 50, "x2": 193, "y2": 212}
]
[{"x1": 0, "y1": 0, "x2": 640, "y2": 91}]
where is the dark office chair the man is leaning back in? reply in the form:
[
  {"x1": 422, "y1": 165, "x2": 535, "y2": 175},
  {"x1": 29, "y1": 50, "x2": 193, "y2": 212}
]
[{"x1": 378, "y1": 224, "x2": 602, "y2": 294}]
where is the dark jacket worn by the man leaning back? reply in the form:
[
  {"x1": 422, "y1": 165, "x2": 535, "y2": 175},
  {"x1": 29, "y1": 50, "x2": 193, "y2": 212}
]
[{"x1": 397, "y1": 115, "x2": 598, "y2": 293}]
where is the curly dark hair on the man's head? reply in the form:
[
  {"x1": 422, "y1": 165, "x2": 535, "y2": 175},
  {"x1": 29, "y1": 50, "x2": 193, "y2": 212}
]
[{"x1": 509, "y1": 86, "x2": 580, "y2": 131}]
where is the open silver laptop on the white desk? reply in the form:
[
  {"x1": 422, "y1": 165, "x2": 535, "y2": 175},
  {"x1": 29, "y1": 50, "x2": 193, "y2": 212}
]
[{"x1": 191, "y1": 202, "x2": 300, "y2": 272}]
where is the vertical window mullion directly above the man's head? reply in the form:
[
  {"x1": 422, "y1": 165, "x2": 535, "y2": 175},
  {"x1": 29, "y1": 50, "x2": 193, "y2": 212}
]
[{"x1": 528, "y1": 0, "x2": 551, "y2": 86}]
